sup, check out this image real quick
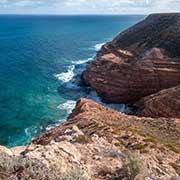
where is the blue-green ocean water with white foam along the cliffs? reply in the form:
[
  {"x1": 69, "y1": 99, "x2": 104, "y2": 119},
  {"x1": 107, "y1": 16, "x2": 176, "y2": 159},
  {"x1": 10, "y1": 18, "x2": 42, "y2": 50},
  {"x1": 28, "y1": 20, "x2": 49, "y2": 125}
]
[{"x1": 0, "y1": 15, "x2": 144, "y2": 146}]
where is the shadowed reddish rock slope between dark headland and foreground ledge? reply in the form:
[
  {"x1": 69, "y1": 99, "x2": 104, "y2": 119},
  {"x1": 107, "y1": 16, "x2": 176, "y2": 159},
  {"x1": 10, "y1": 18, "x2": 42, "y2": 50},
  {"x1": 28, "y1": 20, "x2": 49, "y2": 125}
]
[{"x1": 134, "y1": 86, "x2": 180, "y2": 118}]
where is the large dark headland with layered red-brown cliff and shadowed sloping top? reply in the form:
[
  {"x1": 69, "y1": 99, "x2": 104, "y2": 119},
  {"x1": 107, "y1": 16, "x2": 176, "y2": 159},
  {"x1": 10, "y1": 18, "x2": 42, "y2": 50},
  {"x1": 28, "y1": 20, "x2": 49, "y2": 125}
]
[{"x1": 83, "y1": 14, "x2": 180, "y2": 103}]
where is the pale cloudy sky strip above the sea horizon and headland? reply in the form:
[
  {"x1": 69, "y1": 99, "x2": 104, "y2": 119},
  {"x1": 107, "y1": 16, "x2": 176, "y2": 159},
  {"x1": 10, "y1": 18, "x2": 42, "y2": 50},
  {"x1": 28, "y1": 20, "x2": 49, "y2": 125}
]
[{"x1": 0, "y1": 0, "x2": 180, "y2": 14}]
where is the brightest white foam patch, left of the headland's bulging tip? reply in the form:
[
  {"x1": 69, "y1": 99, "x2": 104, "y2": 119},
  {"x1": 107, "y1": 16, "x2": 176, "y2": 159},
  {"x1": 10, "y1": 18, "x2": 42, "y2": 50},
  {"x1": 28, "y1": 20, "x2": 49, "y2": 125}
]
[{"x1": 54, "y1": 65, "x2": 75, "y2": 83}]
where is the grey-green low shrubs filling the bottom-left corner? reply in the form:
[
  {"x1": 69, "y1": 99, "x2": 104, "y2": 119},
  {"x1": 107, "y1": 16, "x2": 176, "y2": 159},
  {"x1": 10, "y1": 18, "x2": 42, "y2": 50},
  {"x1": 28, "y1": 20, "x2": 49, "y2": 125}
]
[{"x1": 0, "y1": 153, "x2": 60, "y2": 180}]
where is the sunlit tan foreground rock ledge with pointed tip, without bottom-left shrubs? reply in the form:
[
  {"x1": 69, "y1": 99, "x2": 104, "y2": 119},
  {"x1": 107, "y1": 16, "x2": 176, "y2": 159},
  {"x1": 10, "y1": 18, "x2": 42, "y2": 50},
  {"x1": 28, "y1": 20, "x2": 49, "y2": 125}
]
[{"x1": 0, "y1": 99, "x2": 180, "y2": 180}]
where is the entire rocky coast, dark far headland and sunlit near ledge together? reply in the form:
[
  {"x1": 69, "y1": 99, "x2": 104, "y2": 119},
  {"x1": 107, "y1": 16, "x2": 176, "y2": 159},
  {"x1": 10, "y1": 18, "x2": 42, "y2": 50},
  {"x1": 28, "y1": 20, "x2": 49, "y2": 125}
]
[{"x1": 0, "y1": 13, "x2": 180, "y2": 180}]
